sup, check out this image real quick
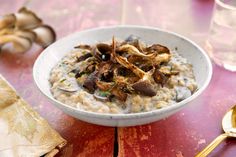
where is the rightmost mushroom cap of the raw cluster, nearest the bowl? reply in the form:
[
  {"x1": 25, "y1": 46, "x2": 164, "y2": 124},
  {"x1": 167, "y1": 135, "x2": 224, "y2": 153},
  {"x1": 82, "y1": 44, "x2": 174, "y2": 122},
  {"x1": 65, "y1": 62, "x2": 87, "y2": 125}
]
[{"x1": 33, "y1": 25, "x2": 56, "y2": 48}]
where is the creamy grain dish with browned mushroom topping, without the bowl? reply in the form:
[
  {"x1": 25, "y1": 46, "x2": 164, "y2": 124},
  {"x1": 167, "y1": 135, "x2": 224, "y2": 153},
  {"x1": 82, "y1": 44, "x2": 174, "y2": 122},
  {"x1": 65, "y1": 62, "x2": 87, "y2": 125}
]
[{"x1": 49, "y1": 35, "x2": 197, "y2": 114}]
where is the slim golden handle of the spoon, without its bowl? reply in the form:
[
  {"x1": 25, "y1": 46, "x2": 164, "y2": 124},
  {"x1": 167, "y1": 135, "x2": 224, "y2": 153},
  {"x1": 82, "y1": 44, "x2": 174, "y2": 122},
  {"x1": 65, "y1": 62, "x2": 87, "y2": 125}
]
[{"x1": 195, "y1": 133, "x2": 228, "y2": 157}]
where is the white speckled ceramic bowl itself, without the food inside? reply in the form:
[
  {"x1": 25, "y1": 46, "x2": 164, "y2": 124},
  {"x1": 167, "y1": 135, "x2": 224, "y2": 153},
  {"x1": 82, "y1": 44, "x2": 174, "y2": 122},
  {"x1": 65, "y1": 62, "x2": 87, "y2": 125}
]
[{"x1": 33, "y1": 26, "x2": 212, "y2": 126}]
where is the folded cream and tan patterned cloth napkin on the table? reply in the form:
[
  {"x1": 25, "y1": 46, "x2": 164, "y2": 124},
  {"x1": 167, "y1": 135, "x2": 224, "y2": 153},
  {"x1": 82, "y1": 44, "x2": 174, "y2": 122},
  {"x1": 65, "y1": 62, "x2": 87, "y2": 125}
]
[{"x1": 0, "y1": 75, "x2": 66, "y2": 157}]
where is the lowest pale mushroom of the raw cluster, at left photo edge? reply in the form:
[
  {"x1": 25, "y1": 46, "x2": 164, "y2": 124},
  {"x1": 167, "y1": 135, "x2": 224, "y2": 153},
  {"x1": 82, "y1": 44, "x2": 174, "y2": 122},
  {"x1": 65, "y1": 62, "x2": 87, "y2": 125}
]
[{"x1": 0, "y1": 35, "x2": 32, "y2": 53}]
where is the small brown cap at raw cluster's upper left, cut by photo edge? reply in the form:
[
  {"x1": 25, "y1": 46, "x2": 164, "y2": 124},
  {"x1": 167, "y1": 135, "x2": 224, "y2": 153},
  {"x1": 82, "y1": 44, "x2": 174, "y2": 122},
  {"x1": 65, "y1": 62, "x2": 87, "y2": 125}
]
[{"x1": 0, "y1": 14, "x2": 16, "y2": 29}]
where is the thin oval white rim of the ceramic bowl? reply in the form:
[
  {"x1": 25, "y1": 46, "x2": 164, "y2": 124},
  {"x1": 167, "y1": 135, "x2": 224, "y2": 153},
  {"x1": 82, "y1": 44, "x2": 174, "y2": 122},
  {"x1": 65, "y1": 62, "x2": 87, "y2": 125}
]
[{"x1": 33, "y1": 25, "x2": 213, "y2": 119}]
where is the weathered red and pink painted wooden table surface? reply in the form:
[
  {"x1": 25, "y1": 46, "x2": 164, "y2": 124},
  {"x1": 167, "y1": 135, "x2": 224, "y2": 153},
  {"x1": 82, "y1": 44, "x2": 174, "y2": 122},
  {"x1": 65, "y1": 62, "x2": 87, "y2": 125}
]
[{"x1": 0, "y1": 0, "x2": 236, "y2": 157}]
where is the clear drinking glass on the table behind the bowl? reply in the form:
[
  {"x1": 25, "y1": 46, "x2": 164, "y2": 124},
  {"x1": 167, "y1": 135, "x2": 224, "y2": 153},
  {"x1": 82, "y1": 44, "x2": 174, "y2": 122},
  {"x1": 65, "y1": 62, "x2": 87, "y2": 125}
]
[{"x1": 206, "y1": 0, "x2": 236, "y2": 71}]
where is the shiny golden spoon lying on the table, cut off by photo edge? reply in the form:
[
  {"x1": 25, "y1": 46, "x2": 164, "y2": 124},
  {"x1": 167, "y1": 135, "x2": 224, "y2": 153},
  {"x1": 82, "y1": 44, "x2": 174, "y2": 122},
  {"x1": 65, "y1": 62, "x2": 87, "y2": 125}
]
[{"x1": 195, "y1": 105, "x2": 236, "y2": 157}]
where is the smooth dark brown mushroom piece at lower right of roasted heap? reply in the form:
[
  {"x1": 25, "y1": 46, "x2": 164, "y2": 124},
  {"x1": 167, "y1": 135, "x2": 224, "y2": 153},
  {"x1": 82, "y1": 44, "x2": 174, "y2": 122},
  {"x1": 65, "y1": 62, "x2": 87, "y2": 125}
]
[{"x1": 132, "y1": 80, "x2": 157, "y2": 96}]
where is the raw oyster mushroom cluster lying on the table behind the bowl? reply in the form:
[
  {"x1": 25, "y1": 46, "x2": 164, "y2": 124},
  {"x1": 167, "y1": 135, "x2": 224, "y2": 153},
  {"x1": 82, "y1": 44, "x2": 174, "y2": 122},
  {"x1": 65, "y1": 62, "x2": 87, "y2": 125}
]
[{"x1": 0, "y1": 7, "x2": 56, "y2": 53}]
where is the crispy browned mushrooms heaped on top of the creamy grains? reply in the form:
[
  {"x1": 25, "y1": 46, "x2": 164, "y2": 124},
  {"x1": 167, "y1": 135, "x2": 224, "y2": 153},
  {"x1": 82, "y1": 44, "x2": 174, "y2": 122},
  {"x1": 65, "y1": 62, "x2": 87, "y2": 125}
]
[{"x1": 71, "y1": 36, "x2": 179, "y2": 102}]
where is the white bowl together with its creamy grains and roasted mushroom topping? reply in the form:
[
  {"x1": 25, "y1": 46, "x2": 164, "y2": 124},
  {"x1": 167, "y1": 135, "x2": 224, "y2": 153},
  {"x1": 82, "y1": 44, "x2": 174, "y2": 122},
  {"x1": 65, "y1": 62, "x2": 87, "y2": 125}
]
[{"x1": 33, "y1": 26, "x2": 212, "y2": 126}]
